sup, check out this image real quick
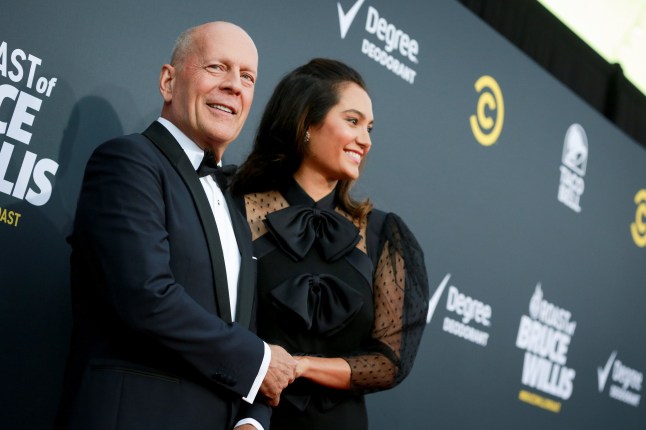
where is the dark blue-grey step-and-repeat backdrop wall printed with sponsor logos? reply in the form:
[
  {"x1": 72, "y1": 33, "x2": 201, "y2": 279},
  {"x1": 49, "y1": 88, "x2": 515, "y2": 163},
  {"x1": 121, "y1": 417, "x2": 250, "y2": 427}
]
[{"x1": 0, "y1": 0, "x2": 646, "y2": 429}]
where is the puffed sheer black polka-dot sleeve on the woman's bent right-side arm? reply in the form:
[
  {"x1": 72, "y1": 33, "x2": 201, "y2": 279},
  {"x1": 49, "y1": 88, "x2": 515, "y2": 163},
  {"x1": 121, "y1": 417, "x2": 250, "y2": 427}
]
[{"x1": 345, "y1": 214, "x2": 429, "y2": 392}]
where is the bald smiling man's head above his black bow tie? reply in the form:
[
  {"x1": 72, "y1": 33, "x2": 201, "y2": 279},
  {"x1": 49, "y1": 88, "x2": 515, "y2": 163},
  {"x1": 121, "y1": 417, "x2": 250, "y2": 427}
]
[{"x1": 161, "y1": 22, "x2": 258, "y2": 160}]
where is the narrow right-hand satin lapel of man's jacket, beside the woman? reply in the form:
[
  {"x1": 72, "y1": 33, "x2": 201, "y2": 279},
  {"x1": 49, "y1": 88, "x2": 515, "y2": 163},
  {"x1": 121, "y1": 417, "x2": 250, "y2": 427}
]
[{"x1": 224, "y1": 190, "x2": 256, "y2": 328}]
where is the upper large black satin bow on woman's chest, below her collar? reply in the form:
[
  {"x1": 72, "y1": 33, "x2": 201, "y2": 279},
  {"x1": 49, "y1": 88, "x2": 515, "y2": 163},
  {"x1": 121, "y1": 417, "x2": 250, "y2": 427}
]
[{"x1": 265, "y1": 205, "x2": 360, "y2": 261}]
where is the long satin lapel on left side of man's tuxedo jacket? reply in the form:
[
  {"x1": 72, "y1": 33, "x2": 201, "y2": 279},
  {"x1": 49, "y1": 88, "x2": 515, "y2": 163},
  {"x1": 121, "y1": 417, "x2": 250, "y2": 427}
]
[{"x1": 143, "y1": 122, "x2": 231, "y2": 322}]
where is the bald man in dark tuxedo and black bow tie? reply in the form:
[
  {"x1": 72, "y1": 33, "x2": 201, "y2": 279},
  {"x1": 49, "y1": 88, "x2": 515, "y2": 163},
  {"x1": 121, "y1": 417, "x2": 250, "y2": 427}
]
[{"x1": 57, "y1": 22, "x2": 296, "y2": 430}]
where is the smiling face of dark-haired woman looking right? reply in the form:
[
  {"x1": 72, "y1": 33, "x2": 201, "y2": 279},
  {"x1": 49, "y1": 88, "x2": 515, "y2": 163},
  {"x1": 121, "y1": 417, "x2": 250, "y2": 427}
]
[{"x1": 301, "y1": 82, "x2": 374, "y2": 181}]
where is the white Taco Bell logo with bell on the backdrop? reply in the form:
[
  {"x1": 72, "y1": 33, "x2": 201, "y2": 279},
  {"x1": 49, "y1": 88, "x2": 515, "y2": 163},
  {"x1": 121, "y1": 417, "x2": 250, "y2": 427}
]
[{"x1": 558, "y1": 124, "x2": 588, "y2": 213}]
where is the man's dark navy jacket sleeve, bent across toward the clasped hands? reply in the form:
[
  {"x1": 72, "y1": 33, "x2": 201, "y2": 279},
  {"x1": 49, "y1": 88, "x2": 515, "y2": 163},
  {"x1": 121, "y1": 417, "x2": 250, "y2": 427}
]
[{"x1": 70, "y1": 136, "x2": 264, "y2": 396}]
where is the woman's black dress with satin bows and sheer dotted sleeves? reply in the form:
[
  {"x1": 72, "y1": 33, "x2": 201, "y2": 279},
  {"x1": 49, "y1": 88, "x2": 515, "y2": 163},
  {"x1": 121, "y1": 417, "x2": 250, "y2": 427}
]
[{"x1": 244, "y1": 181, "x2": 428, "y2": 430}]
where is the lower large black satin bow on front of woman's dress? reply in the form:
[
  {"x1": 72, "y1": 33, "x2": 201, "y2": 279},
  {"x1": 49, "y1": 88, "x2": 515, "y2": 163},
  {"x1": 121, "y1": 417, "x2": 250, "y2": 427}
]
[{"x1": 271, "y1": 273, "x2": 363, "y2": 336}]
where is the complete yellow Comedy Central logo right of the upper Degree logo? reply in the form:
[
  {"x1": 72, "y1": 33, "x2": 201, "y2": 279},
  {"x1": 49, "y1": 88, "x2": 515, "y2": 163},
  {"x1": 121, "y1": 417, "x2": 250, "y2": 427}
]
[{"x1": 469, "y1": 75, "x2": 505, "y2": 146}]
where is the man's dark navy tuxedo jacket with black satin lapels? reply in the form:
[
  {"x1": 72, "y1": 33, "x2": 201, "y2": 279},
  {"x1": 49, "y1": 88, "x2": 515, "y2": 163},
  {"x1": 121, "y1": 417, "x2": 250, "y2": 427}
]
[{"x1": 58, "y1": 122, "x2": 269, "y2": 430}]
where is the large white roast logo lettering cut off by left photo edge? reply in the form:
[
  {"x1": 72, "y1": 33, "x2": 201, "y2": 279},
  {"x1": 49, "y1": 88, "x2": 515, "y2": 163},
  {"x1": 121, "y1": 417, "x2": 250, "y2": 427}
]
[{"x1": 0, "y1": 41, "x2": 58, "y2": 208}]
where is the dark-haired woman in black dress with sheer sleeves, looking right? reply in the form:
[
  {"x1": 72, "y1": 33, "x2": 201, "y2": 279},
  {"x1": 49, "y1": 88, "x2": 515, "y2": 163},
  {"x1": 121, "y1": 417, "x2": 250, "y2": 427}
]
[{"x1": 233, "y1": 59, "x2": 428, "y2": 430}]
